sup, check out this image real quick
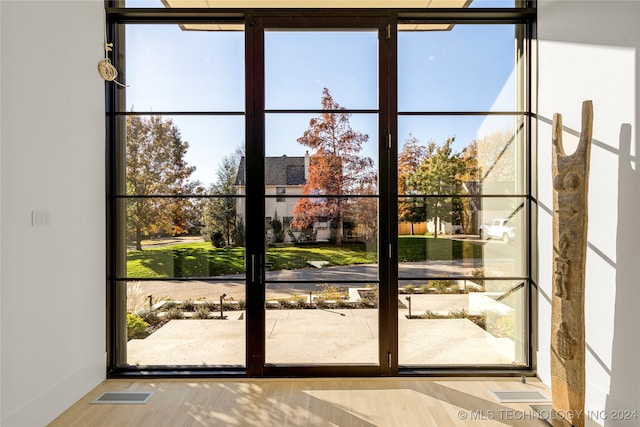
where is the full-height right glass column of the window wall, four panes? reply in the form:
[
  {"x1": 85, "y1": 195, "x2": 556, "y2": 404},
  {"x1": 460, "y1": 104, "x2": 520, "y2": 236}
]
[{"x1": 397, "y1": 24, "x2": 529, "y2": 367}]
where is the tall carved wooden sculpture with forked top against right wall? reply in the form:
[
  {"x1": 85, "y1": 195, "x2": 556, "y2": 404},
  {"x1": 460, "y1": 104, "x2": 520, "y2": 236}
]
[{"x1": 551, "y1": 101, "x2": 593, "y2": 427}]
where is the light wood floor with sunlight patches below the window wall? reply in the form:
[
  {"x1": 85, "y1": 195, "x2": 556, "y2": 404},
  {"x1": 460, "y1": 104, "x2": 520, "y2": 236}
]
[{"x1": 49, "y1": 378, "x2": 551, "y2": 427}]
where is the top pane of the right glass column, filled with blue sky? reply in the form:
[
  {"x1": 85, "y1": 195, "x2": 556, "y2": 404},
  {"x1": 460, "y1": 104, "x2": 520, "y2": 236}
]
[{"x1": 398, "y1": 24, "x2": 517, "y2": 111}]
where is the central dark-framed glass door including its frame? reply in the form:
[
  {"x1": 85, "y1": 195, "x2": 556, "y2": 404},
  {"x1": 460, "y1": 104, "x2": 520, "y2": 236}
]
[{"x1": 246, "y1": 17, "x2": 394, "y2": 375}]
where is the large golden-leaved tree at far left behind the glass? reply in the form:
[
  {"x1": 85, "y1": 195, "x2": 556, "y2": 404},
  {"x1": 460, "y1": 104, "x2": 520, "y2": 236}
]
[{"x1": 126, "y1": 116, "x2": 198, "y2": 250}]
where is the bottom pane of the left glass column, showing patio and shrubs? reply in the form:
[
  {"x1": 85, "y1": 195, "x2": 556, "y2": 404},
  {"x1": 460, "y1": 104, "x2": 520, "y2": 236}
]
[{"x1": 127, "y1": 280, "x2": 246, "y2": 367}]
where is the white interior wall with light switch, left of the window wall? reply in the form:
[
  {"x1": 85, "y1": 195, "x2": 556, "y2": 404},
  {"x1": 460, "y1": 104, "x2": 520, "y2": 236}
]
[{"x1": 0, "y1": 0, "x2": 105, "y2": 427}]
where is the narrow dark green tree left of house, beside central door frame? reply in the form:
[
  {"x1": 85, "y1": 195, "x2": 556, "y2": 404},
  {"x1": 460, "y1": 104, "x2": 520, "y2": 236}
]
[{"x1": 202, "y1": 148, "x2": 244, "y2": 246}]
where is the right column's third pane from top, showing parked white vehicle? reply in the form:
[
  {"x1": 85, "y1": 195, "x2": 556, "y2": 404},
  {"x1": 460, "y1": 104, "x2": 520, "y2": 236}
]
[{"x1": 398, "y1": 197, "x2": 527, "y2": 278}]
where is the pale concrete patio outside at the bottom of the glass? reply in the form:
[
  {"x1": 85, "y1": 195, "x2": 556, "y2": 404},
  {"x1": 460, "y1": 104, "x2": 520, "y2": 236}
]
[{"x1": 127, "y1": 302, "x2": 515, "y2": 366}]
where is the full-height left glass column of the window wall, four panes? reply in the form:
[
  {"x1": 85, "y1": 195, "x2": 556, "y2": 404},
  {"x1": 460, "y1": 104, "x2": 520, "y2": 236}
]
[{"x1": 122, "y1": 24, "x2": 247, "y2": 368}]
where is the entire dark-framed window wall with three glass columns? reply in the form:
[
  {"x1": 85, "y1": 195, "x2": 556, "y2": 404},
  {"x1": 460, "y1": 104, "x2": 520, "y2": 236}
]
[{"x1": 107, "y1": 4, "x2": 535, "y2": 376}]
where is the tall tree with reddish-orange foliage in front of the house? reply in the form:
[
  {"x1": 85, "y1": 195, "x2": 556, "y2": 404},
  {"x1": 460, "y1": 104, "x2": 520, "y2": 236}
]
[{"x1": 291, "y1": 88, "x2": 377, "y2": 244}]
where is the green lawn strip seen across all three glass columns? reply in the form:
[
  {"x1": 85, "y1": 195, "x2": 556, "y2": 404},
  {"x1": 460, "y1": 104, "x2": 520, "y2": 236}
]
[{"x1": 127, "y1": 236, "x2": 482, "y2": 278}]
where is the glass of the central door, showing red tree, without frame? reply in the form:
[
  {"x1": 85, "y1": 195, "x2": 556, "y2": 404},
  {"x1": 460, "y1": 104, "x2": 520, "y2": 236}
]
[{"x1": 264, "y1": 29, "x2": 380, "y2": 366}]
